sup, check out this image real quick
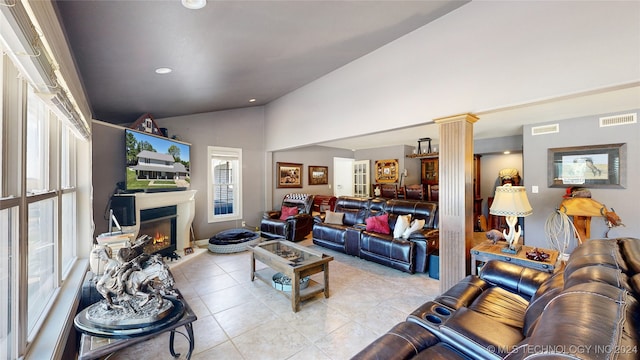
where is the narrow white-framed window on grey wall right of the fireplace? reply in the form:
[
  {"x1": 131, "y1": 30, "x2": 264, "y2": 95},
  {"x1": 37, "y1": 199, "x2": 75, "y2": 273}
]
[{"x1": 207, "y1": 146, "x2": 242, "y2": 222}]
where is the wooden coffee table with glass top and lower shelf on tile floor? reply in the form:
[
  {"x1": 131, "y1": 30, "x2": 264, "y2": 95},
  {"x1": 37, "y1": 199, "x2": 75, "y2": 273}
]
[{"x1": 248, "y1": 240, "x2": 333, "y2": 312}]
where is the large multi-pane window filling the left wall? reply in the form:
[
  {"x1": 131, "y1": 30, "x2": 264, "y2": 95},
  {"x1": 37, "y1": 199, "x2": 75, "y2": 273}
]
[{"x1": 0, "y1": 53, "x2": 88, "y2": 359}]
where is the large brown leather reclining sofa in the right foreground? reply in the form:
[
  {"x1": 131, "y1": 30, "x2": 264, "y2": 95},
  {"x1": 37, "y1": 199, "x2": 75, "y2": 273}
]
[{"x1": 353, "y1": 238, "x2": 640, "y2": 360}]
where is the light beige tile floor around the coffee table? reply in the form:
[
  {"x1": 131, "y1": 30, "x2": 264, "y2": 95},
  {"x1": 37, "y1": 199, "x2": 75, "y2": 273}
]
[{"x1": 109, "y1": 239, "x2": 439, "y2": 360}]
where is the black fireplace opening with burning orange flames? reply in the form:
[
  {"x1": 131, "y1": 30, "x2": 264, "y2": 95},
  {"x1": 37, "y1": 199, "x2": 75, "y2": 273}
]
[{"x1": 138, "y1": 205, "x2": 178, "y2": 259}]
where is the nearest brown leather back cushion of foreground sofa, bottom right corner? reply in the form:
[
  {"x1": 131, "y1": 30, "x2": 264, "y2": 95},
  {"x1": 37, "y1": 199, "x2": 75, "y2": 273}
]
[{"x1": 505, "y1": 282, "x2": 640, "y2": 360}]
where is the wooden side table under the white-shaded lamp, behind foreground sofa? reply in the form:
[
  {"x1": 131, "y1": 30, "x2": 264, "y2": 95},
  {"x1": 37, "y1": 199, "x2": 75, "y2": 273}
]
[{"x1": 471, "y1": 241, "x2": 559, "y2": 275}]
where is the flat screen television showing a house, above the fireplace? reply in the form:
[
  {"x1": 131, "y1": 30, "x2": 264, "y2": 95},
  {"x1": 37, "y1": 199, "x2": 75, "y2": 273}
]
[{"x1": 124, "y1": 129, "x2": 191, "y2": 192}]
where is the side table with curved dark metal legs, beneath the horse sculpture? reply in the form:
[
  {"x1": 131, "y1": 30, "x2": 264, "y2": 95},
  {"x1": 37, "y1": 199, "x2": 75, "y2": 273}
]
[{"x1": 78, "y1": 296, "x2": 198, "y2": 360}]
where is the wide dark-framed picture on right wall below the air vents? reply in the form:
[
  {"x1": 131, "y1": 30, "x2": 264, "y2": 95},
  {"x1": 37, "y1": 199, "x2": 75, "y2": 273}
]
[{"x1": 547, "y1": 144, "x2": 627, "y2": 188}]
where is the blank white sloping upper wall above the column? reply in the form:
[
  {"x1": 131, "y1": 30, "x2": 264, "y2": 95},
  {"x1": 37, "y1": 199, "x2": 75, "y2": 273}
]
[{"x1": 265, "y1": 1, "x2": 640, "y2": 151}]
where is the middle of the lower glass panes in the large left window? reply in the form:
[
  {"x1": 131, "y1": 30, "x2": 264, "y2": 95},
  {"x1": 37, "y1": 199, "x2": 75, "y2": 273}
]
[{"x1": 27, "y1": 198, "x2": 57, "y2": 333}]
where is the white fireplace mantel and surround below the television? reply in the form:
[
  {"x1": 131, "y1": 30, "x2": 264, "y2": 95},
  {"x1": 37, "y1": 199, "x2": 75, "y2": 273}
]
[{"x1": 121, "y1": 190, "x2": 197, "y2": 256}]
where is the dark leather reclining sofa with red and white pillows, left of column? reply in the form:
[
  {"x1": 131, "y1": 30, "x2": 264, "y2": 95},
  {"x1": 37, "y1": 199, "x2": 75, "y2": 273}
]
[{"x1": 312, "y1": 196, "x2": 438, "y2": 273}]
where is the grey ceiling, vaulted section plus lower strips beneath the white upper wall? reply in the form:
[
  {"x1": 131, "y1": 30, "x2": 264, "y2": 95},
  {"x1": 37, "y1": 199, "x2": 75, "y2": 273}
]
[{"x1": 54, "y1": 0, "x2": 640, "y2": 149}]
